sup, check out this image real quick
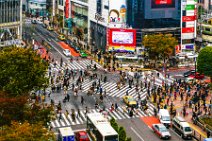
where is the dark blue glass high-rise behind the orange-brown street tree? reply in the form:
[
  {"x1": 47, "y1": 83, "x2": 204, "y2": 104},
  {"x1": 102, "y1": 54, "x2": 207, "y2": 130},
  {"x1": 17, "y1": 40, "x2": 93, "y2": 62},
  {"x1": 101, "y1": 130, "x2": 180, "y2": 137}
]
[{"x1": 127, "y1": 0, "x2": 181, "y2": 46}]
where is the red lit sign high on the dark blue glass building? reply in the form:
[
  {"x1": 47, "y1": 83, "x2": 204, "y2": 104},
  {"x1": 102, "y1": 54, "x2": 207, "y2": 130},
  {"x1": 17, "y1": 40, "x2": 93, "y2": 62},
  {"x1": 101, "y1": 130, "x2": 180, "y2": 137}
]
[{"x1": 151, "y1": 0, "x2": 175, "y2": 8}]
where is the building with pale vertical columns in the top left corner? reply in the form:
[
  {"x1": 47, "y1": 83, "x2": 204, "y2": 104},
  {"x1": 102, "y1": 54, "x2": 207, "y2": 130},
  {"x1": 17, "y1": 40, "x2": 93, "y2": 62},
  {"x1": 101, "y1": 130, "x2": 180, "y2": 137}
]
[{"x1": 0, "y1": 0, "x2": 22, "y2": 46}]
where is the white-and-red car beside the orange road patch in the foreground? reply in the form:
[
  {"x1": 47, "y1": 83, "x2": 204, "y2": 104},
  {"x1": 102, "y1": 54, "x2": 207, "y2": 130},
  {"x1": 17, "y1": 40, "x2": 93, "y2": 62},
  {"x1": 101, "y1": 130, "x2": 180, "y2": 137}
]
[{"x1": 152, "y1": 123, "x2": 171, "y2": 139}]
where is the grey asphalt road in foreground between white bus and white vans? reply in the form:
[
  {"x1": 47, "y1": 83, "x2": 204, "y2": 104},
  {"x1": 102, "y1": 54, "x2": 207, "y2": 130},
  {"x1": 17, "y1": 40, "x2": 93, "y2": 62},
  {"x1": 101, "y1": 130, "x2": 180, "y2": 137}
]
[{"x1": 117, "y1": 118, "x2": 186, "y2": 141}]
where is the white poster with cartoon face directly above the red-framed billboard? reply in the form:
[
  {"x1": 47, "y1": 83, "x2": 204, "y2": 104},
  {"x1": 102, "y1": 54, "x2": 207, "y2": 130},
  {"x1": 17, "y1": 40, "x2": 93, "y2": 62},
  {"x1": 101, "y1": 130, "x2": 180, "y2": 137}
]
[{"x1": 108, "y1": 0, "x2": 127, "y2": 24}]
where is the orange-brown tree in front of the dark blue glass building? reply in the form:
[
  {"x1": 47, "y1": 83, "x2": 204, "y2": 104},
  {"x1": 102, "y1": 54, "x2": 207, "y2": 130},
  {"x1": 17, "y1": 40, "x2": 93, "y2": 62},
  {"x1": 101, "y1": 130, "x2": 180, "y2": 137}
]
[{"x1": 142, "y1": 34, "x2": 178, "y2": 67}]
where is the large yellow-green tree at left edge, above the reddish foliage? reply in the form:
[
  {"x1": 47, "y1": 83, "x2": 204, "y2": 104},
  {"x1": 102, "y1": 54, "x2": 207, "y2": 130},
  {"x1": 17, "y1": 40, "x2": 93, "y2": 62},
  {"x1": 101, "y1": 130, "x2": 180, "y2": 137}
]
[{"x1": 0, "y1": 47, "x2": 48, "y2": 96}]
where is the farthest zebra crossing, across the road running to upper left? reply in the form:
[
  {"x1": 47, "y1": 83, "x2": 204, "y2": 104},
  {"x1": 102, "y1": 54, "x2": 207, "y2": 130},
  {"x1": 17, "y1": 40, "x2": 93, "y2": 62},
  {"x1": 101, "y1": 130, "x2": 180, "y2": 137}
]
[{"x1": 50, "y1": 59, "x2": 102, "y2": 71}]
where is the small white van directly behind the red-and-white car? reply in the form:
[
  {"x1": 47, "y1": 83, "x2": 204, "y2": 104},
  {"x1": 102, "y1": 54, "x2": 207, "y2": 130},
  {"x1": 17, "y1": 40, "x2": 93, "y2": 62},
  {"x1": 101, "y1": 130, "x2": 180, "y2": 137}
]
[{"x1": 158, "y1": 109, "x2": 171, "y2": 127}]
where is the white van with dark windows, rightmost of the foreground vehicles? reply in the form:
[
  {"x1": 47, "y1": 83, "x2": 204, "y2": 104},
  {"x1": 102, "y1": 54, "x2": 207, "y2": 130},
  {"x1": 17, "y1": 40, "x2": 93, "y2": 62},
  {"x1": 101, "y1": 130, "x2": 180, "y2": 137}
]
[{"x1": 172, "y1": 116, "x2": 193, "y2": 139}]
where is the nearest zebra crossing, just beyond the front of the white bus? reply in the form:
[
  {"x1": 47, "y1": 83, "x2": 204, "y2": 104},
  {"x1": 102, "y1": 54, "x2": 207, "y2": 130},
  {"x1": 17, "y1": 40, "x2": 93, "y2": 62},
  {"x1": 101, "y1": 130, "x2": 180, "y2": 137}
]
[{"x1": 50, "y1": 103, "x2": 154, "y2": 128}]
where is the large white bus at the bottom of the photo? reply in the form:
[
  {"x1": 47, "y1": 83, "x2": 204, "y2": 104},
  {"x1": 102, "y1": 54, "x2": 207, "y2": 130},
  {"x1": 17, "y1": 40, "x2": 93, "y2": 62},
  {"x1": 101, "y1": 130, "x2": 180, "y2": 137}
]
[{"x1": 87, "y1": 113, "x2": 119, "y2": 141}]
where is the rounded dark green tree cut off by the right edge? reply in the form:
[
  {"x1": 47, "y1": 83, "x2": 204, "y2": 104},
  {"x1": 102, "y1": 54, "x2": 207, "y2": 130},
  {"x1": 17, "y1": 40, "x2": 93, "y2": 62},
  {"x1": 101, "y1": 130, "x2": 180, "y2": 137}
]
[{"x1": 197, "y1": 47, "x2": 212, "y2": 82}]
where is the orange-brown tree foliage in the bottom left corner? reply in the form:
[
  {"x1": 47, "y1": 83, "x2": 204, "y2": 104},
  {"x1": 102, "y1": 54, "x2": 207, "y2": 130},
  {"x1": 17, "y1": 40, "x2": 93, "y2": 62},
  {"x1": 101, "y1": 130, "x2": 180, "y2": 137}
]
[{"x1": 0, "y1": 121, "x2": 56, "y2": 141}]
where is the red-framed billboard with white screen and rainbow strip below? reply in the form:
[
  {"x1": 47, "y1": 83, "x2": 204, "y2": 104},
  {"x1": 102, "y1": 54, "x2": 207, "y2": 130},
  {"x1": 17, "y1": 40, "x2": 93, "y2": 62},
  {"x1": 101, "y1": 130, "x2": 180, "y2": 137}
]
[{"x1": 108, "y1": 28, "x2": 136, "y2": 52}]
